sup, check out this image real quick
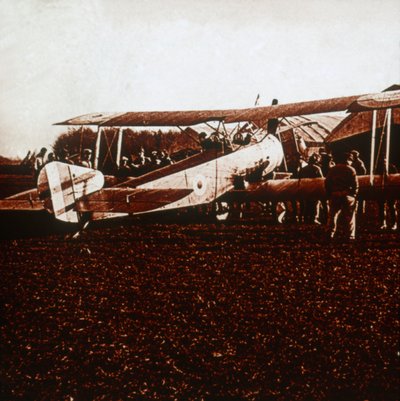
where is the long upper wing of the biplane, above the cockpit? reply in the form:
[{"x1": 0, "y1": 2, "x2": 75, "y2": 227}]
[{"x1": 55, "y1": 90, "x2": 400, "y2": 127}]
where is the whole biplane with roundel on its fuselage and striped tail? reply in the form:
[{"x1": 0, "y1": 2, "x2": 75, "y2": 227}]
[{"x1": 0, "y1": 90, "x2": 400, "y2": 223}]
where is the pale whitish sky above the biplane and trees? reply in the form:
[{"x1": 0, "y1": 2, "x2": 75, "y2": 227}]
[{"x1": 0, "y1": 0, "x2": 400, "y2": 157}]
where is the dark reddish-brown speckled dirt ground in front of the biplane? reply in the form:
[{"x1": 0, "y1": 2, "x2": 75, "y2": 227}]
[{"x1": 0, "y1": 206, "x2": 400, "y2": 401}]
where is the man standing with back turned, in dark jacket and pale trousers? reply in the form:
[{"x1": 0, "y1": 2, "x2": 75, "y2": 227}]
[{"x1": 325, "y1": 153, "x2": 358, "y2": 240}]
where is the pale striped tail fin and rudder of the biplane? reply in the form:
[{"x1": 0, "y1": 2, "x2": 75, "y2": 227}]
[{"x1": 37, "y1": 162, "x2": 104, "y2": 223}]
